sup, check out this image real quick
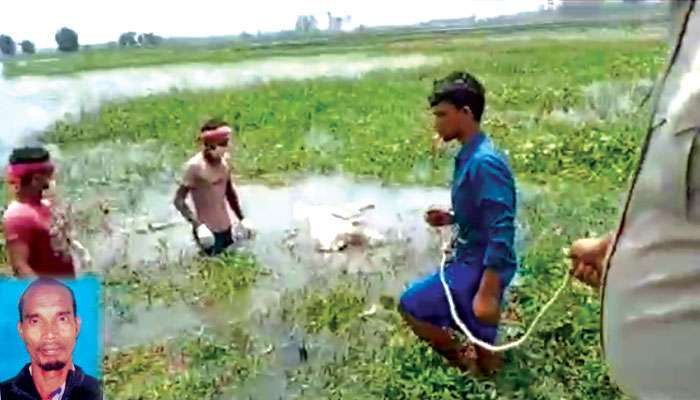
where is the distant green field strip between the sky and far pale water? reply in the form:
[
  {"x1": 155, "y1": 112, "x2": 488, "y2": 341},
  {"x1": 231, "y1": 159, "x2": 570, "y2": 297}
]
[{"x1": 3, "y1": 20, "x2": 663, "y2": 77}]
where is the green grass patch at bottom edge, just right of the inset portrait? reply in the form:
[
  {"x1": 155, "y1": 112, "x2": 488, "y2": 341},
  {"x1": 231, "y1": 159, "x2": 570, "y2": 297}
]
[{"x1": 103, "y1": 326, "x2": 261, "y2": 400}]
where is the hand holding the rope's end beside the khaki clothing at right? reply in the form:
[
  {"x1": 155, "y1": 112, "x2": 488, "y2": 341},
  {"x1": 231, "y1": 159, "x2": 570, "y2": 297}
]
[{"x1": 569, "y1": 234, "x2": 612, "y2": 288}]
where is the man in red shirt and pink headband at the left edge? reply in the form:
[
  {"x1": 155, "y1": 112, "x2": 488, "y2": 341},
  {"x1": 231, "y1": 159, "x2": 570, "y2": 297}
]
[{"x1": 3, "y1": 147, "x2": 76, "y2": 278}]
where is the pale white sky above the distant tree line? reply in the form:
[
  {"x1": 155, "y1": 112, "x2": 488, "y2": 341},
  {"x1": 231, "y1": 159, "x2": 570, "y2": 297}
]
[{"x1": 0, "y1": 0, "x2": 547, "y2": 48}]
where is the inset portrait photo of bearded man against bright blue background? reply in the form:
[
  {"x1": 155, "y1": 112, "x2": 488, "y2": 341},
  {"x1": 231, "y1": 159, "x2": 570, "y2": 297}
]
[{"x1": 0, "y1": 277, "x2": 102, "y2": 400}]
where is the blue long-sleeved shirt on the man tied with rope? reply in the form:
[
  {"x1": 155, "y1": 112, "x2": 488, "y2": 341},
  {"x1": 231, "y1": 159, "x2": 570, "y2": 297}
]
[{"x1": 452, "y1": 132, "x2": 517, "y2": 271}]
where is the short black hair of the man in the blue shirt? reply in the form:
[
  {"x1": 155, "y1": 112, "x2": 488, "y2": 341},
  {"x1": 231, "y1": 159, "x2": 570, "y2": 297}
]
[{"x1": 428, "y1": 71, "x2": 486, "y2": 122}]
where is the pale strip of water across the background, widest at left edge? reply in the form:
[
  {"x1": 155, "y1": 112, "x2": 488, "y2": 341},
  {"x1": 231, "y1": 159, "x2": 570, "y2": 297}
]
[{"x1": 0, "y1": 54, "x2": 440, "y2": 165}]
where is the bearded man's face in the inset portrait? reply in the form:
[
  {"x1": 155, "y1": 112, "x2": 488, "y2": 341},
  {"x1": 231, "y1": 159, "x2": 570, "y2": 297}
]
[{"x1": 17, "y1": 285, "x2": 80, "y2": 371}]
